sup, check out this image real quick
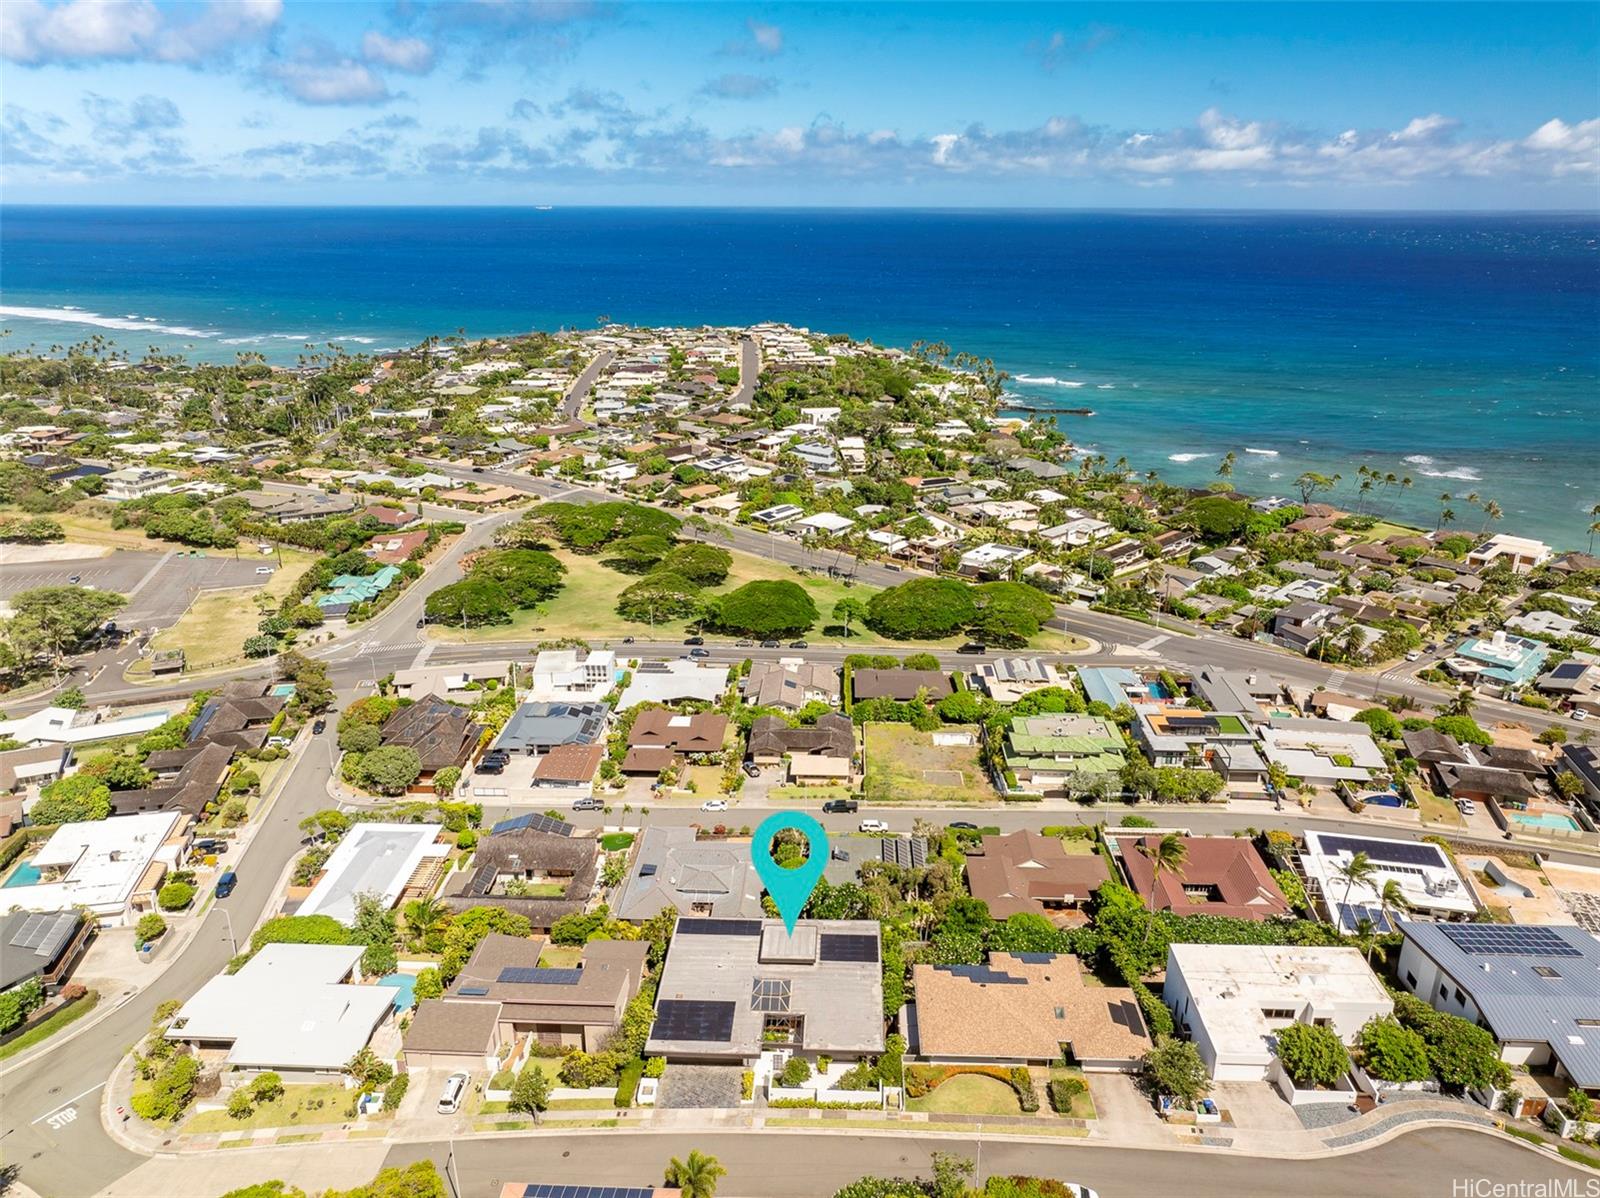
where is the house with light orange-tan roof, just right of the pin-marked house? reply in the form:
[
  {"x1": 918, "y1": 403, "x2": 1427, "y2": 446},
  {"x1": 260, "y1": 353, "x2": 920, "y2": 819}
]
[{"x1": 907, "y1": 953, "x2": 1150, "y2": 1072}]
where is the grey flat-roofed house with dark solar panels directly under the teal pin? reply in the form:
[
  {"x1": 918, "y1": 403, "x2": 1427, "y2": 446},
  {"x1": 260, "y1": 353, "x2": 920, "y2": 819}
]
[{"x1": 645, "y1": 918, "x2": 883, "y2": 1065}]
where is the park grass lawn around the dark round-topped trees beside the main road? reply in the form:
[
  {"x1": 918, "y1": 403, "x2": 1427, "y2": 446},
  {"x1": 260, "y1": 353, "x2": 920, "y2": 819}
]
[{"x1": 429, "y1": 545, "x2": 1086, "y2": 653}]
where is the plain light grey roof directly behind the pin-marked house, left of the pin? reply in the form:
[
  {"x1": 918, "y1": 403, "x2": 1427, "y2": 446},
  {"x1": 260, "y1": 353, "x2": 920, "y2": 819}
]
[{"x1": 614, "y1": 825, "x2": 762, "y2": 923}]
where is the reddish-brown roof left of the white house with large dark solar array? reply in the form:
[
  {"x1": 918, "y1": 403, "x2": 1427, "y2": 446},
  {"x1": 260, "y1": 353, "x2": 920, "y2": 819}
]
[{"x1": 1122, "y1": 837, "x2": 1290, "y2": 920}]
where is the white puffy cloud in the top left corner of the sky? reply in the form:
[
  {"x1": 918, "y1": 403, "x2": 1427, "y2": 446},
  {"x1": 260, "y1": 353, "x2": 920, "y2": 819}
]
[{"x1": 0, "y1": 0, "x2": 283, "y2": 66}]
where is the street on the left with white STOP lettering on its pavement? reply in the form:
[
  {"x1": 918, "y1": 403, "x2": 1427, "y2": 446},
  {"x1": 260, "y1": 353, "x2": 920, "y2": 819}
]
[{"x1": 0, "y1": 728, "x2": 344, "y2": 1198}]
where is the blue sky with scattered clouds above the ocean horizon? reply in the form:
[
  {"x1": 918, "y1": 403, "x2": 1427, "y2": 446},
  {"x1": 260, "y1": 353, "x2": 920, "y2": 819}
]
[{"x1": 0, "y1": 0, "x2": 1600, "y2": 210}]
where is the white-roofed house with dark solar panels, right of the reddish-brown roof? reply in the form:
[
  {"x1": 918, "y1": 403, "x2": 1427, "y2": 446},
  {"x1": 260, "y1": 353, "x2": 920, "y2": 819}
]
[{"x1": 1301, "y1": 832, "x2": 1478, "y2": 934}]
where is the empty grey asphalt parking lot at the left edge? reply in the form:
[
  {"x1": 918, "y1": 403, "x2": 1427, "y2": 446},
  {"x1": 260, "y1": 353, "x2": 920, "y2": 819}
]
[{"x1": 0, "y1": 549, "x2": 274, "y2": 629}]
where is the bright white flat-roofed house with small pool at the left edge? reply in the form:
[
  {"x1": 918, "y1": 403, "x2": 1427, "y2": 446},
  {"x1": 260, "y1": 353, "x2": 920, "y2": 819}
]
[{"x1": 0, "y1": 811, "x2": 190, "y2": 928}]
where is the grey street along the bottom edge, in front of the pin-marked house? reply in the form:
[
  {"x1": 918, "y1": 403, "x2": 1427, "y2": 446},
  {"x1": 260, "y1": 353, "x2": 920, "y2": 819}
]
[{"x1": 380, "y1": 1128, "x2": 1592, "y2": 1198}]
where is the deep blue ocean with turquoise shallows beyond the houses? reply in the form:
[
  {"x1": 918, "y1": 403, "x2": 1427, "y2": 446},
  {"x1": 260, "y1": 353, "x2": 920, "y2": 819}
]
[{"x1": 0, "y1": 208, "x2": 1600, "y2": 547}]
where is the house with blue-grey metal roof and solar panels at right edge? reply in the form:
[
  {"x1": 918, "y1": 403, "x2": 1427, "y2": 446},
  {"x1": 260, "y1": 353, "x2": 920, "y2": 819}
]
[{"x1": 1395, "y1": 920, "x2": 1600, "y2": 1097}]
